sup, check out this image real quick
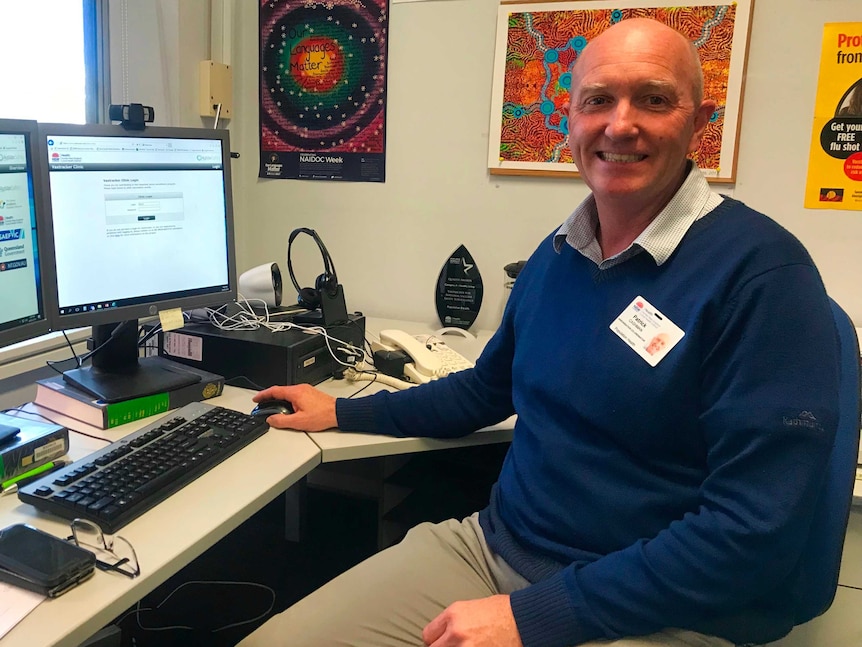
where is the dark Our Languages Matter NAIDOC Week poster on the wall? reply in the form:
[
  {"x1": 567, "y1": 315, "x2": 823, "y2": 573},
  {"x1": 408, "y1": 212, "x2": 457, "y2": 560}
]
[{"x1": 259, "y1": 0, "x2": 389, "y2": 182}]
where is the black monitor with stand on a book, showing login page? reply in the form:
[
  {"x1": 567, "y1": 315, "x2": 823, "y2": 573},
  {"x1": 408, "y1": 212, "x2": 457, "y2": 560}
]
[{"x1": 39, "y1": 124, "x2": 237, "y2": 402}]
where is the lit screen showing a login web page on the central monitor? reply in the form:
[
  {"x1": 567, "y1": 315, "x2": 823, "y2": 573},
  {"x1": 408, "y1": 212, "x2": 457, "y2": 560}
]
[{"x1": 47, "y1": 134, "x2": 229, "y2": 314}]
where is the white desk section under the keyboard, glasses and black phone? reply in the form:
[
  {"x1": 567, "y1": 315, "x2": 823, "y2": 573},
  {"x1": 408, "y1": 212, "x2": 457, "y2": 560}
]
[{"x1": 0, "y1": 387, "x2": 320, "y2": 647}]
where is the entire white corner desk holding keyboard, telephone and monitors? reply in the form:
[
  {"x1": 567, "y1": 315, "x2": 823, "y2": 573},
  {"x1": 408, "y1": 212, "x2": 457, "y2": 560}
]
[{"x1": 0, "y1": 319, "x2": 513, "y2": 647}]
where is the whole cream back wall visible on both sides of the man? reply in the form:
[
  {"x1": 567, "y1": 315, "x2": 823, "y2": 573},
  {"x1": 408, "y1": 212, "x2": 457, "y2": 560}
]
[{"x1": 120, "y1": 0, "x2": 862, "y2": 327}]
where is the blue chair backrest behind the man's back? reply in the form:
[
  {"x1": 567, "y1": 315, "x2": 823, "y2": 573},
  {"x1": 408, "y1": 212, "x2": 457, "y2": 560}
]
[{"x1": 794, "y1": 301, "x2": 862, "y2": 624}]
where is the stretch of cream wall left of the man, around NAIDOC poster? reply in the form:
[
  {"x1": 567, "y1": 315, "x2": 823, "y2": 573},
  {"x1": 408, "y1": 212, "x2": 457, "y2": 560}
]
[{"x1": 231, "y1": 0, "x2": 586, "y2": 327}]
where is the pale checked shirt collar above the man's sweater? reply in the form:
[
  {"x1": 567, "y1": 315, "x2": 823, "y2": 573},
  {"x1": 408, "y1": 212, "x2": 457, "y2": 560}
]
[{"x1": 554, "y1": 162, "x2": 722, "y2": 270}]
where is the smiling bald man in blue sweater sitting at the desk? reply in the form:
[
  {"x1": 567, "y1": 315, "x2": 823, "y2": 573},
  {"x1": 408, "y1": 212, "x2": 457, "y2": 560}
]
[{"x1": 236, "y1": 19, "x2": 838, "y2": 647}]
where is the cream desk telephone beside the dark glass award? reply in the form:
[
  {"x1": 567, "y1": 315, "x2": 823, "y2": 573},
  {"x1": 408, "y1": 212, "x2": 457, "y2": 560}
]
[{"x1": 371, "y1": 330, "x2": 480, "y2": 384}]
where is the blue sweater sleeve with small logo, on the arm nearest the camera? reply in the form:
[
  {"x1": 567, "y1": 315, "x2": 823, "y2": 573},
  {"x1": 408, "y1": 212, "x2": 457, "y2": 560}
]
[{"x1": 511, "y1": 265, "x2": 838, "y2": 647}]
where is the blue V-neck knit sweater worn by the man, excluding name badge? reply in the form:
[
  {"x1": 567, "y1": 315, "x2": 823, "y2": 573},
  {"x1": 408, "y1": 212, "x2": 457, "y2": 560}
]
[{"x1": 336, "y1": 199, "x2": 838, "y2": 647}]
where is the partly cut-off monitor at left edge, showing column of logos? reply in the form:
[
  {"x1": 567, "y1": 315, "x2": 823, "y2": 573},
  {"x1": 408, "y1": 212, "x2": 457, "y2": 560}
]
[{"x1": 0, "y1": 119, "x2": 50, "y2": 347}]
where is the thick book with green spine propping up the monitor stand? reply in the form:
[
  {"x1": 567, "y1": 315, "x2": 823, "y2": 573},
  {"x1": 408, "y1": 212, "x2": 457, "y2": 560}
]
[{"x1": 34, "y1": 366, "x2": 224, "y2": 429}]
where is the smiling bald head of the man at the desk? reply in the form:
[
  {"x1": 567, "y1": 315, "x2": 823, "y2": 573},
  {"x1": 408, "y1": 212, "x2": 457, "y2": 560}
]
[{"x1": 569, "y1": 19, "x2": 715, "y2": 216}]
